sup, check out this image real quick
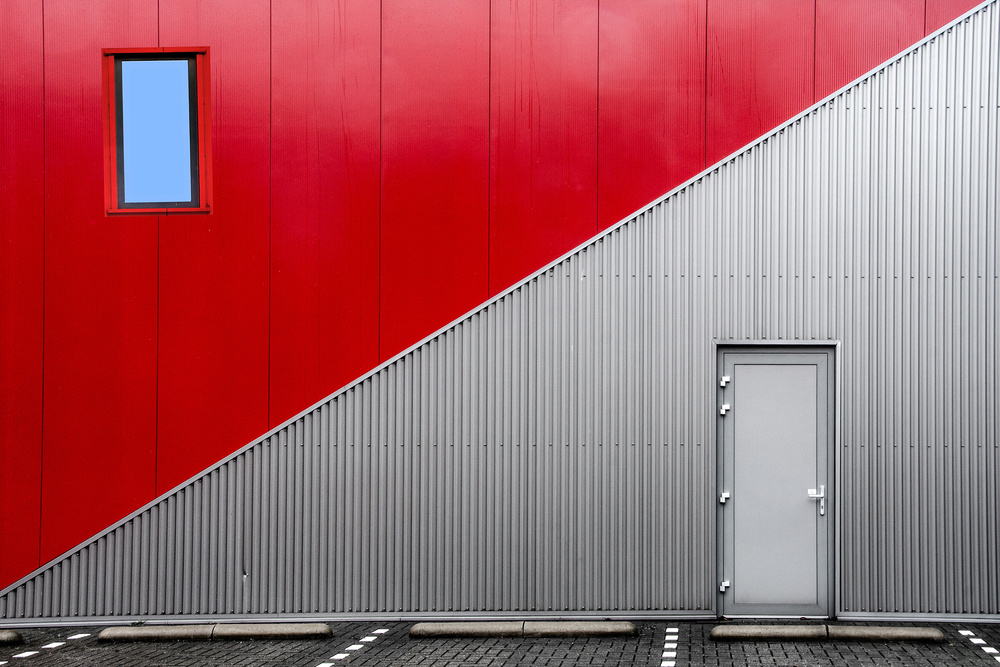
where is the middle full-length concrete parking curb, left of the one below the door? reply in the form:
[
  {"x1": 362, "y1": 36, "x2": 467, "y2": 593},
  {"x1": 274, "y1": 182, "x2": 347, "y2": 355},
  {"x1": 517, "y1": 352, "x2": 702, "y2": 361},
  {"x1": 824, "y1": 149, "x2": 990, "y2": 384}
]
[{"x1": 410, "y1": 621, "x2": 637, "y2": 639}]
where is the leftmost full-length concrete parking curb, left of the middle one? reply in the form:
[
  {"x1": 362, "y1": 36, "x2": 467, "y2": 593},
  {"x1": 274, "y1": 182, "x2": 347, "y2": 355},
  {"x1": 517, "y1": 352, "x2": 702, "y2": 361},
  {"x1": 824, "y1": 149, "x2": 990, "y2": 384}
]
[{"x1": 97, "y1": 623, "x2": 333, "y2": 642}]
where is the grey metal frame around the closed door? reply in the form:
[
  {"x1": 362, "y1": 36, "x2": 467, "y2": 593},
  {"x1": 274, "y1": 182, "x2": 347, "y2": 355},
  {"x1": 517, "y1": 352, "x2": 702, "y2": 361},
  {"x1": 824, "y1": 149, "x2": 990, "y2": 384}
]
[{"x1": 713, "y1": 340, "x2": 841, "y2": 618}]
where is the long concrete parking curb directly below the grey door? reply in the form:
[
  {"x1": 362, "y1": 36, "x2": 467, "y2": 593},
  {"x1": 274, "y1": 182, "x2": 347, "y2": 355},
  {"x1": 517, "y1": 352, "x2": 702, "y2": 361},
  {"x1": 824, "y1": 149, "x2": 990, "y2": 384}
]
[{"x1": 709, "y1": 625, "x2": 945, "y2": 643}]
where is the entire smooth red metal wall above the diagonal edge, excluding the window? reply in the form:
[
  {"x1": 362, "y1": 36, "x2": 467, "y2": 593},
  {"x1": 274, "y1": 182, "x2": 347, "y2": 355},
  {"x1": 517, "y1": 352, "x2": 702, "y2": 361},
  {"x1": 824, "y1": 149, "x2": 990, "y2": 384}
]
[{"x1": 0, "y1": 0, "x2": 975, "y2": 586}]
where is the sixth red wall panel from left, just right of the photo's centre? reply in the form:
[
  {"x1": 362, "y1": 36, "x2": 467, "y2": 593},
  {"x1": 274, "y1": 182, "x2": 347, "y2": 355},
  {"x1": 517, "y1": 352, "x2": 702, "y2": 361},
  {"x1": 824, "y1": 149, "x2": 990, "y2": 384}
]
[{"x1": 489, "y1": 0, "x2": 598, "y2": 294}]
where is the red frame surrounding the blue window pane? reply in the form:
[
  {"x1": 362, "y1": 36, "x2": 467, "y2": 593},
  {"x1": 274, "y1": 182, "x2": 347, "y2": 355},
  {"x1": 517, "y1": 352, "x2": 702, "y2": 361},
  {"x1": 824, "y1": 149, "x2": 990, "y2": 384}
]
[{"x1": 101, "y1": 46, "x2": 212, "y2": 215}]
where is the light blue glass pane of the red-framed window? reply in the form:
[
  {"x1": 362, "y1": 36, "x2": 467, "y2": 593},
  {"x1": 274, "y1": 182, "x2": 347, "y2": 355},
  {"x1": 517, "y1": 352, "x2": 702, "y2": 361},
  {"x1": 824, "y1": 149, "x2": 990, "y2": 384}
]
[{"x1": 121, "y1": 60, "x2": 191, "y2": 204}]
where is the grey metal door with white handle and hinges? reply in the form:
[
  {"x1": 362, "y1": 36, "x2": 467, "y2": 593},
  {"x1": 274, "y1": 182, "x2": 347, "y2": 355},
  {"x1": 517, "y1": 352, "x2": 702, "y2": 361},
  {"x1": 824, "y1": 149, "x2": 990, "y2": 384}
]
[{"x1": 718, "y1": 347, "x2": 834, "y2": 617}]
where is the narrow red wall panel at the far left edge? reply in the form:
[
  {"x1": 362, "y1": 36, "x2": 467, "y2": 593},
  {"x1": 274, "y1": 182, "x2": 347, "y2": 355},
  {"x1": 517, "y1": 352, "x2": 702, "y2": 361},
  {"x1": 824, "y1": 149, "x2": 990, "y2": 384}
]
[{"x1": 0, "y1": 1, "x2": 45, "y2": 587}]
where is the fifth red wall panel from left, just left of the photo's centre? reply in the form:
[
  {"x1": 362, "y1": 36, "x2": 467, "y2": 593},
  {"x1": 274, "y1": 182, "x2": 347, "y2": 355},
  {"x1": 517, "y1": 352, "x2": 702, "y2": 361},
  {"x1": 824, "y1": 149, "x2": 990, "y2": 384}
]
[{"x1": 379, "y1": 0, "x2": 490, "y2": 359}]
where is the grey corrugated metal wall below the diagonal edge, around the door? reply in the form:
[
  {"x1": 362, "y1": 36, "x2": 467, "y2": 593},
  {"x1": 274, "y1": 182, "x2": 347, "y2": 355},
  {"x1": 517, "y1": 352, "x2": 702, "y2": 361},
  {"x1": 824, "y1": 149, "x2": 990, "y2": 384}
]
[{"x1": 0, "y1": 2, "x2": 1000, "y2": 621}]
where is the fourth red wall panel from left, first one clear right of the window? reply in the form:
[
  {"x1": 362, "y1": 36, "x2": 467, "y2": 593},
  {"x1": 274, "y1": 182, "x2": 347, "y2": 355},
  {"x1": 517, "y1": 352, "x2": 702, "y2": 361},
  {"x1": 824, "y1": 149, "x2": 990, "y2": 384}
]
[{"x1": 269, "y1": 0, "x2": 381, "y2": 427}]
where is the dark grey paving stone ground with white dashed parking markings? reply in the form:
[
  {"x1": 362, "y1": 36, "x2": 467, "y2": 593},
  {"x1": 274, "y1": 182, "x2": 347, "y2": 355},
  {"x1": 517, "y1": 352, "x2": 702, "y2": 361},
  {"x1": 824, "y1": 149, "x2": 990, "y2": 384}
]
[{"x1": 0, "y1": 621, "x2": 1000, "y2": 667}]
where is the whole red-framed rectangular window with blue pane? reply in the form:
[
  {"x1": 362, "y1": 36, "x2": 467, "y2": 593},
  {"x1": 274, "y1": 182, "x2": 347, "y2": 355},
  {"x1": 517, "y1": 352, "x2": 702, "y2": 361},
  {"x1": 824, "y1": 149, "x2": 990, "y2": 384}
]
[{"x1": 103, "y1": 47, "x2": 212, "y2": 215}]
